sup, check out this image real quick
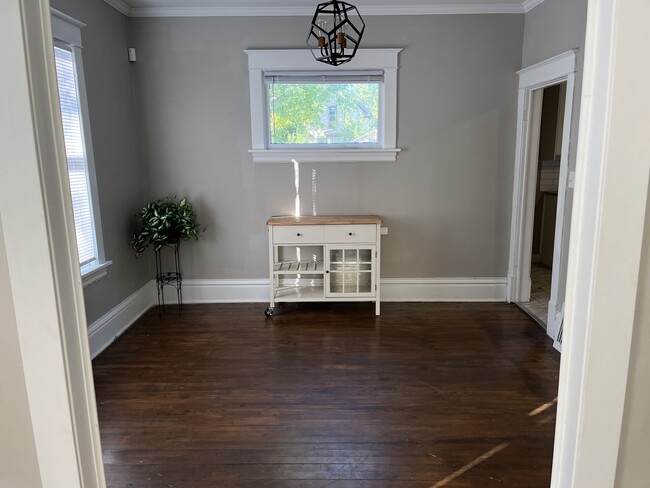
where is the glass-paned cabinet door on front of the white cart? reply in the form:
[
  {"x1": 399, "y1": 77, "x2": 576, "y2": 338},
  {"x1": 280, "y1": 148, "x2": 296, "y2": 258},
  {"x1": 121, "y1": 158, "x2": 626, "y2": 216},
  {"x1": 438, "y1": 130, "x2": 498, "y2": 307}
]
[{"x1": 325, "y1": 245, "x2": 376, "y2": 298}]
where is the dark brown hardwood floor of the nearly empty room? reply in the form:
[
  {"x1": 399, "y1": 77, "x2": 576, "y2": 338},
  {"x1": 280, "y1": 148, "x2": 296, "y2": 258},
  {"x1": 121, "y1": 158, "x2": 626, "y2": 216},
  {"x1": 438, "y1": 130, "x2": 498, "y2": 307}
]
[{"x1": 93, "y1": 303, "x2": 559, "y2": 488}]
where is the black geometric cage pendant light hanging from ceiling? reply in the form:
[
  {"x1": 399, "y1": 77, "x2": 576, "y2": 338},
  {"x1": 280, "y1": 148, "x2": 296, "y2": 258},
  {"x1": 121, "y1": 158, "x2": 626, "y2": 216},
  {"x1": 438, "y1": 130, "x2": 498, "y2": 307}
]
[{"x1": 307, "y1": 0, "x2": 366, "y2": 66}]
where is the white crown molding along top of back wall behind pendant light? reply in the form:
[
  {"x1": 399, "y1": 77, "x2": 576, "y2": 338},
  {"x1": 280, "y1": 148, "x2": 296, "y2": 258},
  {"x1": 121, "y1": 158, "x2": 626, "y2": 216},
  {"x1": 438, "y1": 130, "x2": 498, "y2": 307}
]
[{"x1": 125, "y1": 0, "x2": 520, "y2": 17}]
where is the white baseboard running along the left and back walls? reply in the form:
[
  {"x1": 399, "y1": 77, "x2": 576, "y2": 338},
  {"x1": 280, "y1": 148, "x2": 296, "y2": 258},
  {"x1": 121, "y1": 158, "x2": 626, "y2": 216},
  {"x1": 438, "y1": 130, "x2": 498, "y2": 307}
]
[{"x1": 88, "y1": 278, "x2": 508, "y2": 358}]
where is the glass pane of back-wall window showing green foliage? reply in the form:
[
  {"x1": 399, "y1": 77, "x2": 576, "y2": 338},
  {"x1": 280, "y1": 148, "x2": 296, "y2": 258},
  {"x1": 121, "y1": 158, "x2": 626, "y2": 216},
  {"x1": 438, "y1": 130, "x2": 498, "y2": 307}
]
[{"x1": 267, "y1": 82, "x2": 379, "y2": 145}]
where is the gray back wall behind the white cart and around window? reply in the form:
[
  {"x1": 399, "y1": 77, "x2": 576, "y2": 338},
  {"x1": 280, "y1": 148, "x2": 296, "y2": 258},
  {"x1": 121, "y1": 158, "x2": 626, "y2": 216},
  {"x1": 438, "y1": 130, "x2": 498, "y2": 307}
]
[{"x1": 129, "y1": 15, "x2": 524, "y2": 278}]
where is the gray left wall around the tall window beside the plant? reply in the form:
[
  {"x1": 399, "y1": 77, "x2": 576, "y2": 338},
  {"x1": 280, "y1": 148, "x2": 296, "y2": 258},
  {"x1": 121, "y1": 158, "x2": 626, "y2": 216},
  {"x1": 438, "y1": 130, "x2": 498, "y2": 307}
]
[{"x1": 52, "y1": 0, "x2": 152, "y2": 324}]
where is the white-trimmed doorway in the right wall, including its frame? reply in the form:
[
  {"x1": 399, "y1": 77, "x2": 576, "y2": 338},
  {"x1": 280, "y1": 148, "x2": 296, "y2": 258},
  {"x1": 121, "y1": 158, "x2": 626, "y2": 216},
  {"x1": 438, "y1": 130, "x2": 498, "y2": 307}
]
[{"x1": 508, "y1": 51, "x2": 575, "y2": 339}]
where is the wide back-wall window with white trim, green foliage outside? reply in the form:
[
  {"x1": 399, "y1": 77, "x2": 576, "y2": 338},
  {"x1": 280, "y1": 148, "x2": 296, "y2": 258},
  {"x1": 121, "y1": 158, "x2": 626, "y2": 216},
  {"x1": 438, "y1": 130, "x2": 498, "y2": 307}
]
[{"x1": 246, "y1": 49, "x2": 400, "y2": 162}]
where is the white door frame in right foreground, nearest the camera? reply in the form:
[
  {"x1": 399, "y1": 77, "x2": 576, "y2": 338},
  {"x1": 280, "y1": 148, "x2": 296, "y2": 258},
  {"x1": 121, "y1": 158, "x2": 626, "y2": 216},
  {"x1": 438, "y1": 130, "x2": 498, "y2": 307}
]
[{"x1": 551, "y1": 0, "x2": 650, "y2": 488}]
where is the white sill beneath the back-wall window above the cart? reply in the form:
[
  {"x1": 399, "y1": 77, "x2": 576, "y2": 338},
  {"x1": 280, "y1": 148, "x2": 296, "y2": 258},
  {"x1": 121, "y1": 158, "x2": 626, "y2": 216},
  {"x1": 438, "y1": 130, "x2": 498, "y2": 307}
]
[{"x1": 248, "y1": 148, "x2": 401, "y2": 163}]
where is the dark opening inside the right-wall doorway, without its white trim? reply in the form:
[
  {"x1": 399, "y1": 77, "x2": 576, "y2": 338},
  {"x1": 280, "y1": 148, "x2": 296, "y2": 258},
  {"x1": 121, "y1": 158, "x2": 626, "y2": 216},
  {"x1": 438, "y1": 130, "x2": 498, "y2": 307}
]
[{"x1": 517, "y1": 81, "x2": 566, "y2": 329}]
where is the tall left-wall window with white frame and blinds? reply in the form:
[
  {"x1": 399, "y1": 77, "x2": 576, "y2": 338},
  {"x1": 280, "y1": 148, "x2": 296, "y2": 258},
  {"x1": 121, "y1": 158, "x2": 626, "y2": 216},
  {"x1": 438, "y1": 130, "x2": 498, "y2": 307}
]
[{"x1": 52, "y1": 12, "x2": 111, "y2": 286}]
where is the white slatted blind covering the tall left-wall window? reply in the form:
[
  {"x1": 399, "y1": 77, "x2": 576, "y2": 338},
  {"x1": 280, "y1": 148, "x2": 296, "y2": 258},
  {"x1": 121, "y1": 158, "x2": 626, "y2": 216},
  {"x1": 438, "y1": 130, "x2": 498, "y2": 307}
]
[{"x1": 54, "y1": 46, "x2": 97, "y2": 267}]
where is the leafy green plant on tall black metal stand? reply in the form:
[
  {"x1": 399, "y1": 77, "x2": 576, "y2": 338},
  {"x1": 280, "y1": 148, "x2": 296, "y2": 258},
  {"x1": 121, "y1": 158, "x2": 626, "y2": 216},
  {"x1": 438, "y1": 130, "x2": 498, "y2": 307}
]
[{"x1": 130, "y1": 195, "x2": 205, "y2": 313}]
